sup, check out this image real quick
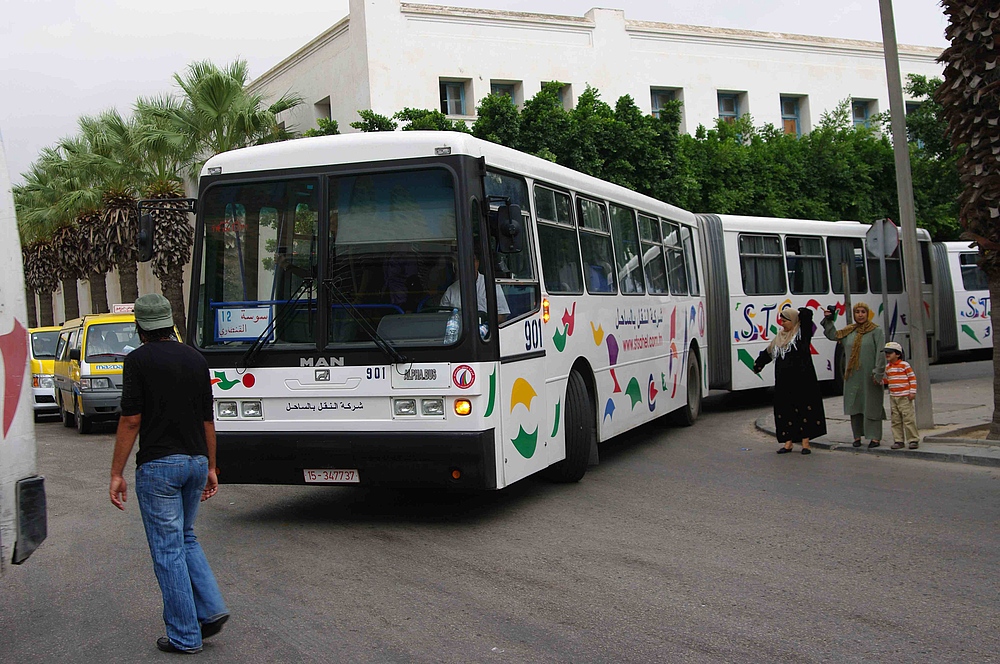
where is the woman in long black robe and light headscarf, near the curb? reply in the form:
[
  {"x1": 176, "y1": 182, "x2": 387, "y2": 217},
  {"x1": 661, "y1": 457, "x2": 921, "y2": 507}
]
[{"x1": 753, "y1": 307, "x2": 826, "y2": 454}]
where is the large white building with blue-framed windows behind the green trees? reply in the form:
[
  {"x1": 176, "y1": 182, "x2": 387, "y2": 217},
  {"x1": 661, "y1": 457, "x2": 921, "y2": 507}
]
[{"x1": 251, "y1": 0, "x2": 943, "y2": 133}]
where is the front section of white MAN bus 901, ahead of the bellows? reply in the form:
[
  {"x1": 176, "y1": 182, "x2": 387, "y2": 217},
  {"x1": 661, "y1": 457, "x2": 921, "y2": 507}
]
[{"x1": 158, "y1": 131, "x2": 707, "y2": 489}]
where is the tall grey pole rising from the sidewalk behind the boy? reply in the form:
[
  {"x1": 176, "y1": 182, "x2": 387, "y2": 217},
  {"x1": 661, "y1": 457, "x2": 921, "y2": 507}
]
[{"x1": 879, "y1": 0, "x2": 934, "y2": 429}]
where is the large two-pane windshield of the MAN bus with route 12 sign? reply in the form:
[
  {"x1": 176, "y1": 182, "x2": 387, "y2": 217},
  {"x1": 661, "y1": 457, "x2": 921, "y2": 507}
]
[{"x1": 197, "y1": 168, "x2": 461, "y2": 348}]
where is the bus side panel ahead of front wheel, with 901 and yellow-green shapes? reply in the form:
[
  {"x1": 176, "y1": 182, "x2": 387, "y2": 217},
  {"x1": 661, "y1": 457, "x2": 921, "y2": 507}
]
[{"x1": 491, "y1": 217, "x2": 562, "y2": 486}]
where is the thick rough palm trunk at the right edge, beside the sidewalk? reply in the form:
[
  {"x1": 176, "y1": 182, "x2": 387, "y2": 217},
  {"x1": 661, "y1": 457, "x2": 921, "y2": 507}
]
[{"x1": 934, "y1": 0, "x2": 1000, "y2": 440}]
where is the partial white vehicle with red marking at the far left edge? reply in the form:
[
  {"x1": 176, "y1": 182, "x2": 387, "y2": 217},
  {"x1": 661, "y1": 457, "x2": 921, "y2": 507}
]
[{"x1": 0, "y1": 131, "x2": 47, "y2": 570}]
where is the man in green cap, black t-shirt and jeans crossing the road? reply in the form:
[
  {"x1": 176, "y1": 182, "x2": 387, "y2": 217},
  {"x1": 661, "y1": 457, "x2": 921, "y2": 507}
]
[{"x1": 111, "y1": 294, "x2": 229, "y2": 654}]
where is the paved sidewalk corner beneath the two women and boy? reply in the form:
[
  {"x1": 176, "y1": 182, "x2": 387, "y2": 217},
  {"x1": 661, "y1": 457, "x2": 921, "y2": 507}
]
[{"x1": 755, "y1": 368, "x2": 1000, "y2": 467}]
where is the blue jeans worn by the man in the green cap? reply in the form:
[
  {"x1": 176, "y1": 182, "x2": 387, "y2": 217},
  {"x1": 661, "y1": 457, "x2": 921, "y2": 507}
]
[{"x1": 135, "y1": 454, "x2": 228, "y2": 650}]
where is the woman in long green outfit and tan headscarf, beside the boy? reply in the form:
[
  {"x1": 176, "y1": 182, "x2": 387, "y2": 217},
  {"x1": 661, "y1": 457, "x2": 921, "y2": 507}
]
[{"x1": 823, "y1": 302, "x2": 885, "y2": 448}]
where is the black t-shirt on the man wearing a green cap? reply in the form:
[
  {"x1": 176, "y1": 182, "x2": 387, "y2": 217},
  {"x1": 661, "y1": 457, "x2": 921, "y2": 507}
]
[{"x1": 122, "y1": 341, "x2": 214, "y2": 465}]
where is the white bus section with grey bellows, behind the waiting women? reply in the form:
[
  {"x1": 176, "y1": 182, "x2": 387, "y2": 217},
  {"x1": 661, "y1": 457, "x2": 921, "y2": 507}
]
[{"x1": 698, "y1": 214, "x2": 936, "y2": 391}]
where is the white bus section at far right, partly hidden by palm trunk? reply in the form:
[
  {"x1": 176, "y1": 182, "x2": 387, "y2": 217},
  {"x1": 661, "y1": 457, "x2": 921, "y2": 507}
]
[{"x1": 934, "y1": 242, "x2": 993, "y2": 353}]
